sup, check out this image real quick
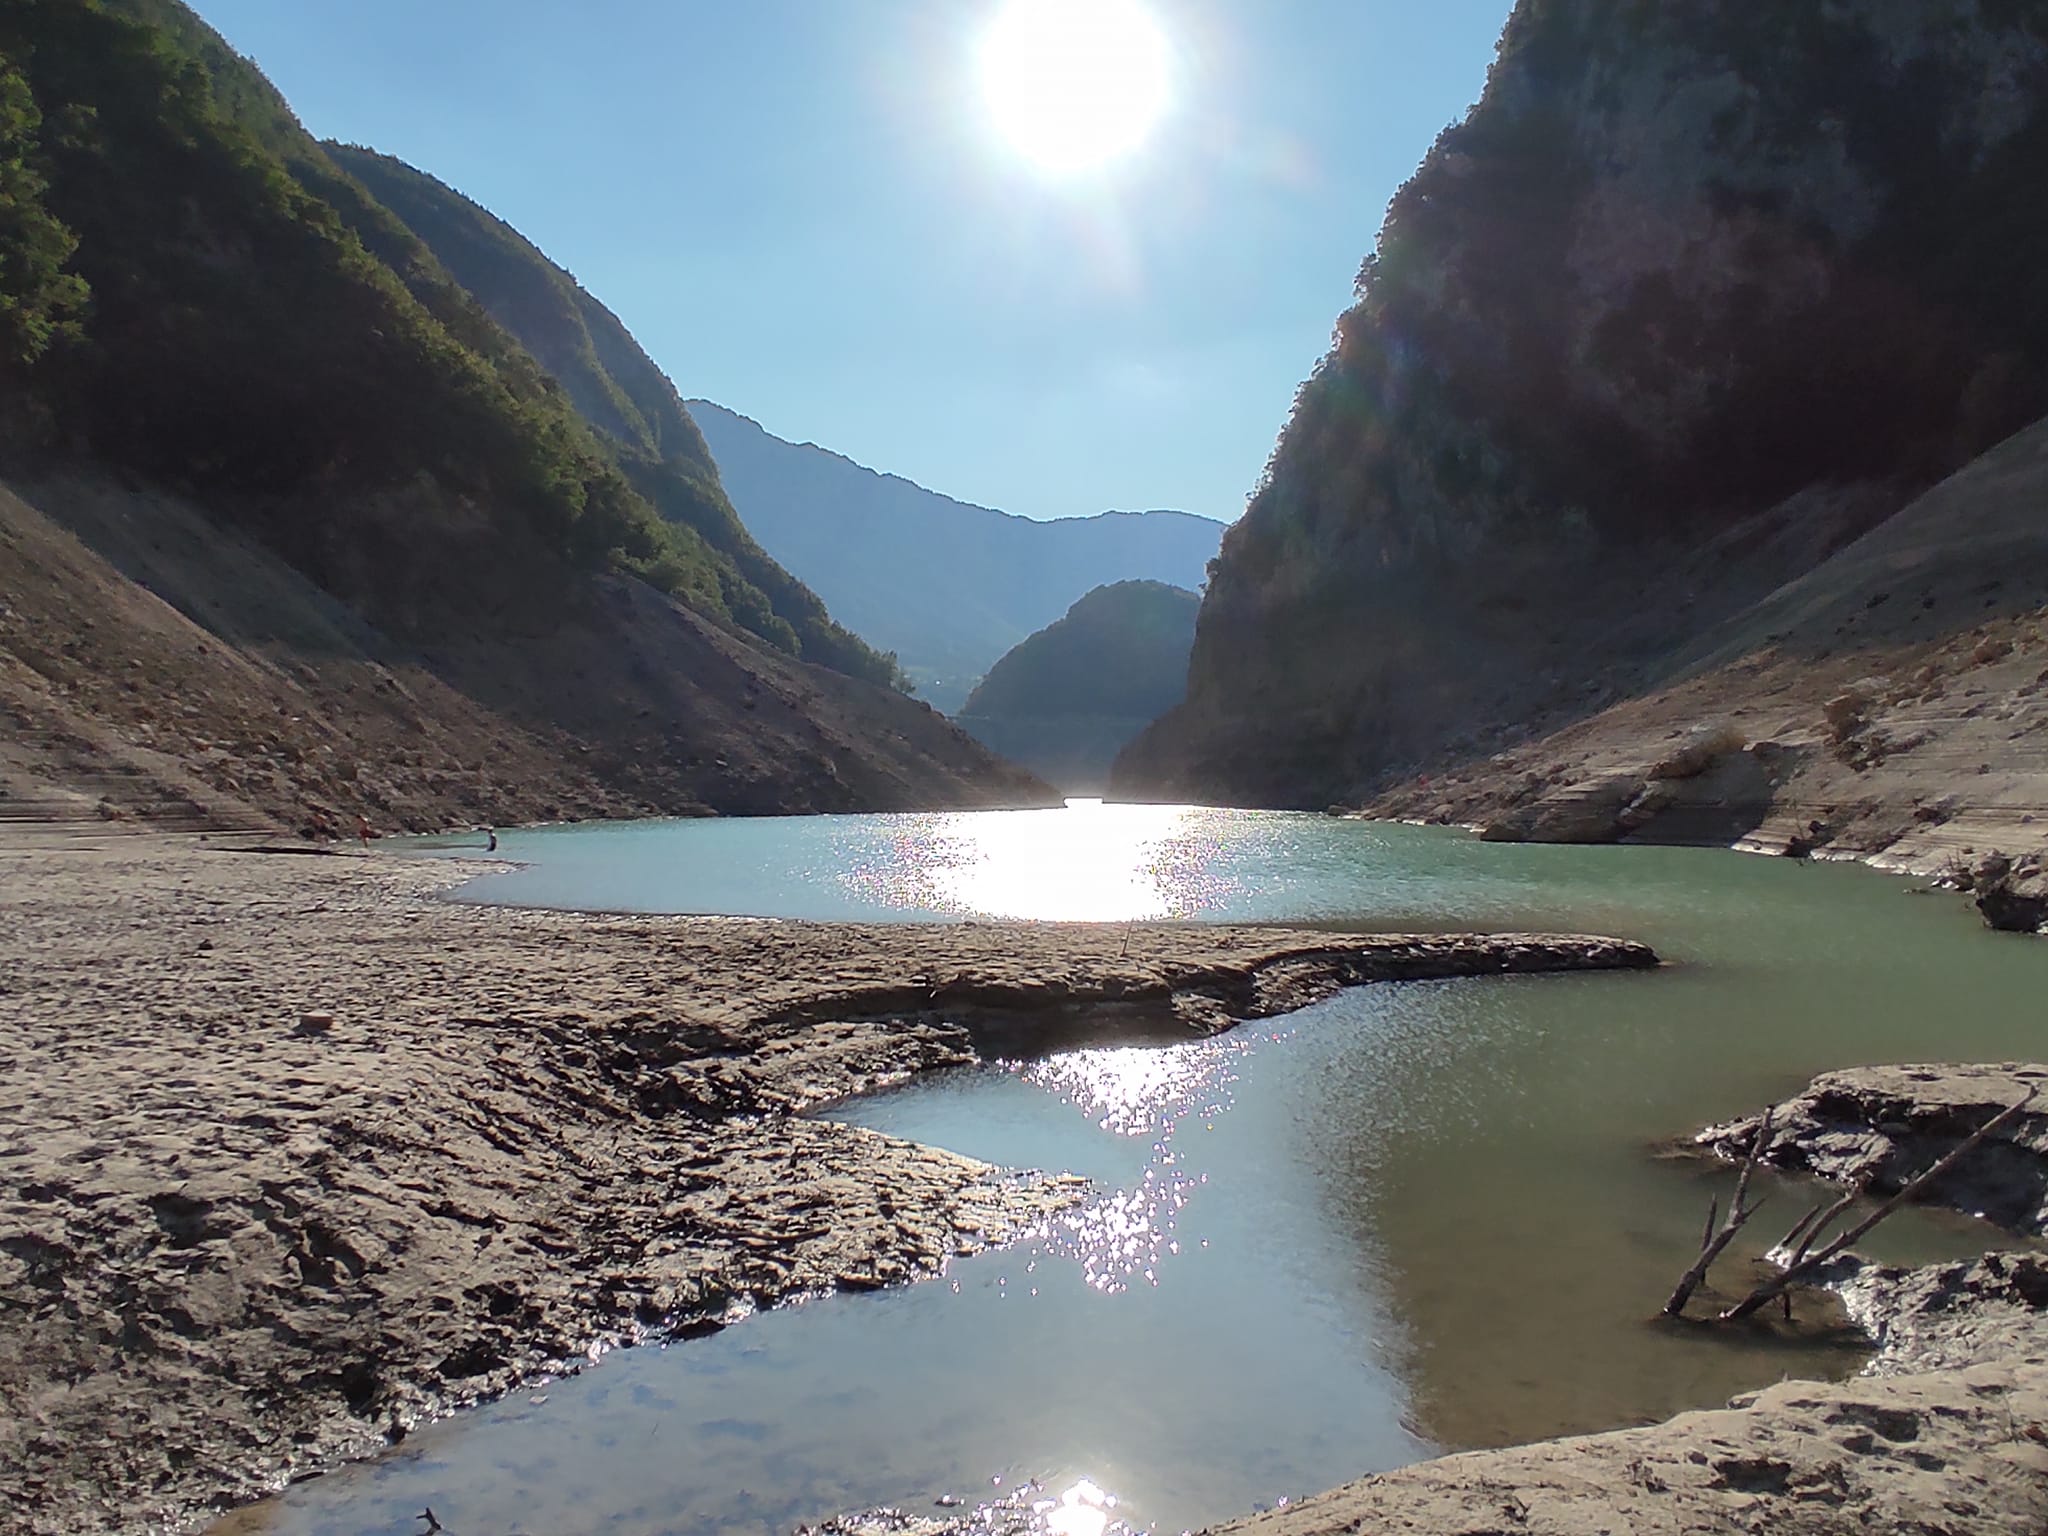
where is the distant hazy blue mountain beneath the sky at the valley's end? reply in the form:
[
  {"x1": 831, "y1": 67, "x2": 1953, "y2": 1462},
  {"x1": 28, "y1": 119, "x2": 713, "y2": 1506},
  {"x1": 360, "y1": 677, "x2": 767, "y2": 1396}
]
[{"x1": 690, "y1": 399, "x2": 1223, "y2": 711}]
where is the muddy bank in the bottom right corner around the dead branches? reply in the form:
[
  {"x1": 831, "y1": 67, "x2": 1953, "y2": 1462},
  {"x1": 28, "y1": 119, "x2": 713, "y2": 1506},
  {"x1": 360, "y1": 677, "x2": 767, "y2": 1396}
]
[{"x1": 801, "y1": 1065, "x2": 2048, "y2": 1536}]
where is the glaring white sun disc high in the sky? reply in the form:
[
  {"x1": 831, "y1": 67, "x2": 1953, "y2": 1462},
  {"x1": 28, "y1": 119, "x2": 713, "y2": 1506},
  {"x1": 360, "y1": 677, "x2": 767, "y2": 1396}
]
[{"x1": 981, "y1": 0, "x2": 1169, "y2": 176}]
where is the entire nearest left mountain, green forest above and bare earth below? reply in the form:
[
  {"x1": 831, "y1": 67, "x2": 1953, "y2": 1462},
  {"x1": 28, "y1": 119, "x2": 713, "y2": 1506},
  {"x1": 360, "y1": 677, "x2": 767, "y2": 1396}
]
[{"x1": 0, "y1": 0, "x2": 1047, "y2": 829}]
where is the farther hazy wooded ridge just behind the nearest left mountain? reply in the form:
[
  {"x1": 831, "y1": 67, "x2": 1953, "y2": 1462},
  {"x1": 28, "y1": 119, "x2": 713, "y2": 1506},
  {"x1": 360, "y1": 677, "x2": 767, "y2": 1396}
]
[{"x1": 324, "y1": 143, "x2": 897, "y2": 684}]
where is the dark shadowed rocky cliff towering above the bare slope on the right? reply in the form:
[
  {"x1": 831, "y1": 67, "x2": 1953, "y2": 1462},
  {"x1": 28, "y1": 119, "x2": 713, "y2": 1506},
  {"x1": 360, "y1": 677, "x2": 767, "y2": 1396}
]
[{"x1": 1118, "y1": 0, "x2": 2048, "y2": 805}]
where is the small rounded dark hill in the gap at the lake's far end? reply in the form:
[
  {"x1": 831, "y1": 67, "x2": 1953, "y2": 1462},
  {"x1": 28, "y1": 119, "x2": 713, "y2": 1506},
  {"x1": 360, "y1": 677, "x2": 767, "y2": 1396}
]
[{"x1": 958, "y1": 582, "x2": 1202, "y2": 795}]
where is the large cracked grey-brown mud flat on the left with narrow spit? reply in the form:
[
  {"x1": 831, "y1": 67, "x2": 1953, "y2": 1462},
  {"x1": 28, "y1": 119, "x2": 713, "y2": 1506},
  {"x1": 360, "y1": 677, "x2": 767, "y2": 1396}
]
[{"x1": 0, "y1": 829, "x2": 1655, "y2": 1536}]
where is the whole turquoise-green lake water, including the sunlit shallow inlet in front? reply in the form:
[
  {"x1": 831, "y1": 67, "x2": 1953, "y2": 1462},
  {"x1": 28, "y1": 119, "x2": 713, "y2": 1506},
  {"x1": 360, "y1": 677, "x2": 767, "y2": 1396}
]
[{"x1": 242, "y1": 807, "x2": 2048, "y2": 1536}]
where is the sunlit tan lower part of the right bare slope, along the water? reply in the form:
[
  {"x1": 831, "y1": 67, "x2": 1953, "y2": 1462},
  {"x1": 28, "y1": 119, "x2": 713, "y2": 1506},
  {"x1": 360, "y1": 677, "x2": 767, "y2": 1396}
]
[{"x1": 1360, "y1": 581, "x2": 2048, "y2": 932}]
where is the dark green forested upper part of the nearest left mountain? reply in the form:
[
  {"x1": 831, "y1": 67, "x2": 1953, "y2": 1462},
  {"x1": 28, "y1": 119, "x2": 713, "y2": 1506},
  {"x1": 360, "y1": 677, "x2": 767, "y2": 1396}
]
[{"x1": 0, "y1": 0, "x2": 719, "y2": 623}]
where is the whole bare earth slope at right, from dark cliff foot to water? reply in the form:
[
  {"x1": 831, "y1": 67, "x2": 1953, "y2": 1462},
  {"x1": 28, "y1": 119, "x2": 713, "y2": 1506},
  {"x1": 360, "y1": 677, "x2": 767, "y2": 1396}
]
[{"x1": 1370, "y1": 424, "x2": 2048, "y2": 901}]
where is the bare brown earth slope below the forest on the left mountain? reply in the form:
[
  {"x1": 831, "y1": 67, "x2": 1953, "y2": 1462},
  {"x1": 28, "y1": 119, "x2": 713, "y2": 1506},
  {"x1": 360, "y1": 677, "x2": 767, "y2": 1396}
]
[{"x1": 0, "y1": 481, "x2": 1051, "y2": 834}]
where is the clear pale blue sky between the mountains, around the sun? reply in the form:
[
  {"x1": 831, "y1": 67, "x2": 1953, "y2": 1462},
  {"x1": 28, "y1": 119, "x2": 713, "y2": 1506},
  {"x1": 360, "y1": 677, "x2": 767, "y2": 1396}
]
[{"x1": 197, "y1": 0, "x2": 1509, "y2": 518}]
